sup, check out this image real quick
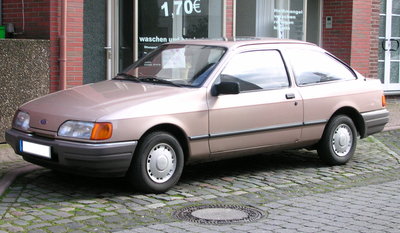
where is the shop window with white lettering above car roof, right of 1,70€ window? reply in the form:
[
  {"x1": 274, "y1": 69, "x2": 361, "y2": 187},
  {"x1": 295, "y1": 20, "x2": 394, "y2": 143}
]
[{"x1": 236, "y1": 0, "x2": 320, "y2": 43}]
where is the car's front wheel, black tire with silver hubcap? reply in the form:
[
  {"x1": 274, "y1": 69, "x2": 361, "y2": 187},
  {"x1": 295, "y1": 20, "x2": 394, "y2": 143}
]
[{"x1": 127, "y1": 131, "x2": 184, "y2": 193}]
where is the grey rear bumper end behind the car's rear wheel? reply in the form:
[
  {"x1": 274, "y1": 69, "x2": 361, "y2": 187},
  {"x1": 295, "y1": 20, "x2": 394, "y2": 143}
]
[{"x1": 361, "y1": 109, "x2": 389, "y2": 138}]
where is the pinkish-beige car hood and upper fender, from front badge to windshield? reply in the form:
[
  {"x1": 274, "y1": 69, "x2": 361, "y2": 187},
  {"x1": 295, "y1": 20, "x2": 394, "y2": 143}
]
[{"x1": 20, "y1": 80, "x2": 205, "y2": 131}]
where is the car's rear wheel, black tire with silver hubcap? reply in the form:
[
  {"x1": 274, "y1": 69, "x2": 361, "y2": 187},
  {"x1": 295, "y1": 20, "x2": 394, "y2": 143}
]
[{"x1": 317, "y1": 115, "x2": 357, "y2": 165}]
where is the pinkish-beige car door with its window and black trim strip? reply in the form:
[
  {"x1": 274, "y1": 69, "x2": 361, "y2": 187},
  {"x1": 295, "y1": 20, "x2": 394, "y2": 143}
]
[{"x1": 208, "y1": 50, "x2": 303, "y2": 153}]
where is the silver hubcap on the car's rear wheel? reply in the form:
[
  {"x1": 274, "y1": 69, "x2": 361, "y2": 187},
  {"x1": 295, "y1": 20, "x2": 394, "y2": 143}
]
[{"x1": 332, "y1": 124, "x2": 353, "y2": 157}]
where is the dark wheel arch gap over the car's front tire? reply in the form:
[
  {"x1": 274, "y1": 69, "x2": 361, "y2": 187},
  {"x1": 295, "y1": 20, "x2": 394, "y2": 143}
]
[{"x1": 139, "y1": 123, "x2": 190, "y2": 164}]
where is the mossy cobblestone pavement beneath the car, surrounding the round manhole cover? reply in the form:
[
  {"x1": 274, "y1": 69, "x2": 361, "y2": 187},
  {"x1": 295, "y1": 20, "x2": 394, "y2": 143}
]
[{"x1": 0, "y1": 130, "x2": 400, "y2": 233}]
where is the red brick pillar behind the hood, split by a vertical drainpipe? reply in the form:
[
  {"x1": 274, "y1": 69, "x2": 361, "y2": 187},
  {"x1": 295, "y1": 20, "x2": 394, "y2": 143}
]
[{"x1": 50, "y1": 0, "x2": 83, "y2": 92}]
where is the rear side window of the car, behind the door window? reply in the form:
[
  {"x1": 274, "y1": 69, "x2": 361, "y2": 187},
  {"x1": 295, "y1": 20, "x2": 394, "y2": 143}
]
[{"x1": 287, "y1": 49, "x2": 356, "y2": 86}]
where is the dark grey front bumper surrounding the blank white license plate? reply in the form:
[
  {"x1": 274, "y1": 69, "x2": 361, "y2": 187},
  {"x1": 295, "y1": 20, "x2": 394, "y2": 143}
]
[{"x1": 6, "y1": 129, "x2": 137, "y2": 177}]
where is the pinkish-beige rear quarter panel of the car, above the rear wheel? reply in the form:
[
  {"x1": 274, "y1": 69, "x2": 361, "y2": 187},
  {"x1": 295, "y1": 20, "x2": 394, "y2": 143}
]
[{"x1": 298, "y1": 78, "x2": 384, "y2": 141}]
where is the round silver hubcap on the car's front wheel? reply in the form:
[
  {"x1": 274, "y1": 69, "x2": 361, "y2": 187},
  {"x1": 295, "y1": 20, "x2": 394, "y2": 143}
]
[{"x1": 146, "y1": 143, "x2": 176, "y2": 183}]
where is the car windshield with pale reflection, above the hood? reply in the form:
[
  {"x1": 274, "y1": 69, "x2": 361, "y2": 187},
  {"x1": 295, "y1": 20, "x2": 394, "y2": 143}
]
[{"x1": 119, "y1": 45, "x2": 226, "y2": 87}]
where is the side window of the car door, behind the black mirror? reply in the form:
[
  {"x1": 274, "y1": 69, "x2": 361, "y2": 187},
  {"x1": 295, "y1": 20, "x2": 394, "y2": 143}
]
[{"x1": 220, "y1": 50, "x2": 289, "y2": 92}]
